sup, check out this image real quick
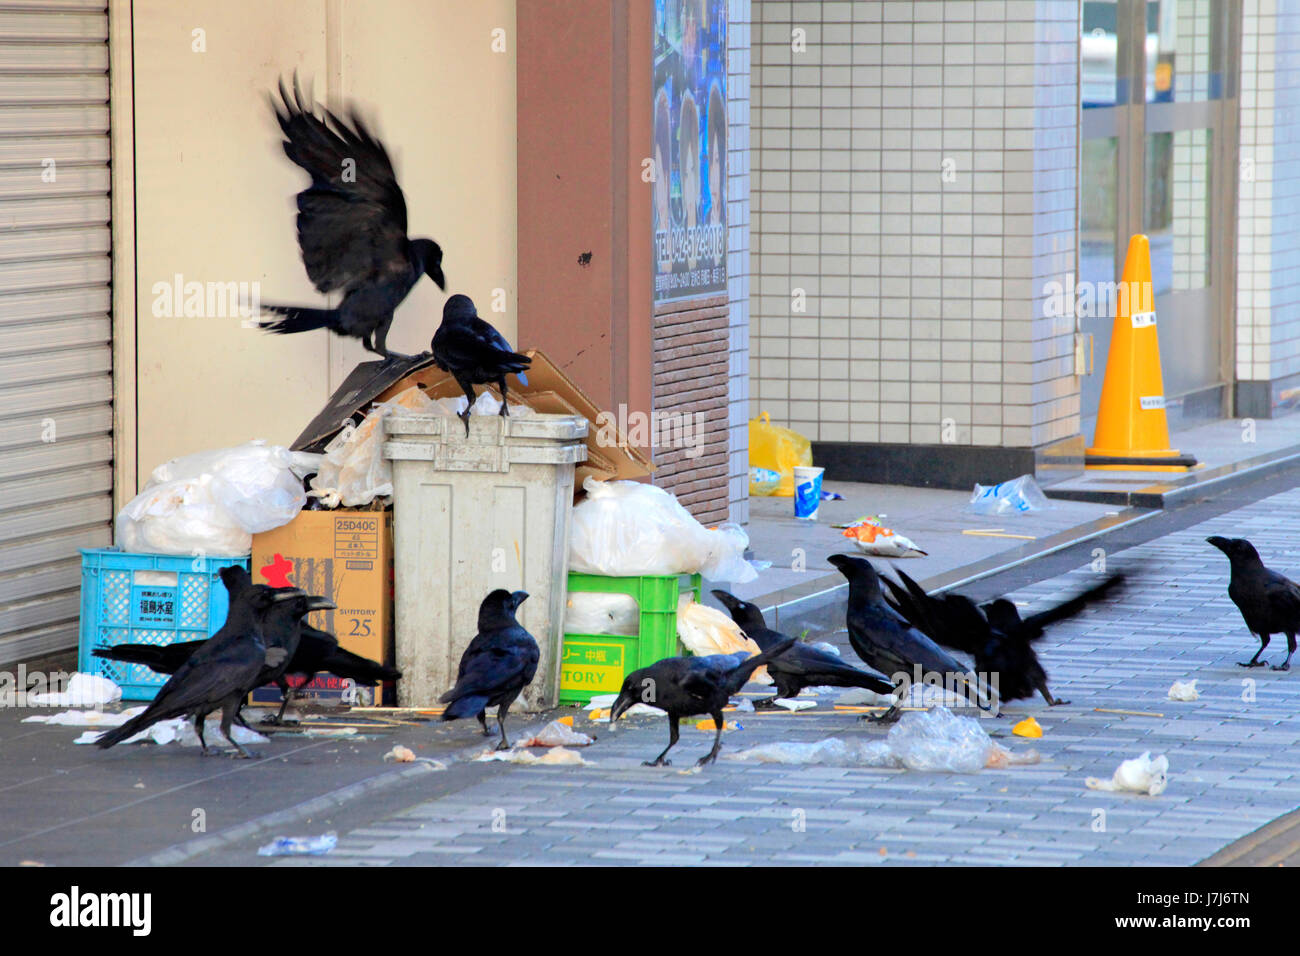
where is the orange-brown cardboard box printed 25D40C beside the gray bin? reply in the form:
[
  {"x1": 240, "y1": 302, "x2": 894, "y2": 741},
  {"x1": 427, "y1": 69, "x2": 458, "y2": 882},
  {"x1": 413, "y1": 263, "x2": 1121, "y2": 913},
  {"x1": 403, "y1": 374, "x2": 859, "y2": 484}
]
[{"x1": 250, "y1": 509, "x2": 394, "y2": 704}]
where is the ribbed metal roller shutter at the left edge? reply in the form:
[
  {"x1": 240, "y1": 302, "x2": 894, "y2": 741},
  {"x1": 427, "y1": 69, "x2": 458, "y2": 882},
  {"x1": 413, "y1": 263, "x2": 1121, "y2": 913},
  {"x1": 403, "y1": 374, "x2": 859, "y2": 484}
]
[{"x1": 0, "y1": 0, "x2": 113, "y2": 666}]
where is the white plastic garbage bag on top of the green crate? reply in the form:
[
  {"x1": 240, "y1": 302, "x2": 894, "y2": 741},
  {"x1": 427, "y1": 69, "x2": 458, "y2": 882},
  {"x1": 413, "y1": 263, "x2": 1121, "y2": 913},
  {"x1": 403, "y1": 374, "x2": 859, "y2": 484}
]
[{"x1": 569, "y1": 477, "x2": 758, "y2": 584}]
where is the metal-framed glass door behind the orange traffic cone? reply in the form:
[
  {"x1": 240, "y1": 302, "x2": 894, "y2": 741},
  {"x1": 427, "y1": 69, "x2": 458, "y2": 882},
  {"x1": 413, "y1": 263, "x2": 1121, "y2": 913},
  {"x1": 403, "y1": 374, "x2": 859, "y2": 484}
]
[{"x1": 1079, "y1": 0, "x2": 1240, "y2": 436}]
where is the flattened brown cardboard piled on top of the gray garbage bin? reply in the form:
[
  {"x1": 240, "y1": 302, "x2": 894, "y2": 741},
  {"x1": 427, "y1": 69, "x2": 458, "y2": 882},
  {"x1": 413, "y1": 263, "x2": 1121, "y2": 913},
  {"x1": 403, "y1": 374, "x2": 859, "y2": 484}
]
[{"x1": 294, "y1": 349, "x2": 654, "y2": 496}]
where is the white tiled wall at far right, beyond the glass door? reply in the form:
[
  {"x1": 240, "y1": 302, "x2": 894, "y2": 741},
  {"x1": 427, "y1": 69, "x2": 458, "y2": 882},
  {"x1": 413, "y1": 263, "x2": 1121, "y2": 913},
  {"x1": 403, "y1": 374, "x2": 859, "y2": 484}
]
[{"x1": 1236, "y1": 0, "x2": 1300, "y2": 390}]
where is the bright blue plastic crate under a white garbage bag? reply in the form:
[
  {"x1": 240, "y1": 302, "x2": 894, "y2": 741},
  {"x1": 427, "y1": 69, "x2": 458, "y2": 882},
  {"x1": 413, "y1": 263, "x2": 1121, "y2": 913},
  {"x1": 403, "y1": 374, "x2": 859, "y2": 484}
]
[{"x1": 77, "y1": 548, "x2": 248, "y2": 700}]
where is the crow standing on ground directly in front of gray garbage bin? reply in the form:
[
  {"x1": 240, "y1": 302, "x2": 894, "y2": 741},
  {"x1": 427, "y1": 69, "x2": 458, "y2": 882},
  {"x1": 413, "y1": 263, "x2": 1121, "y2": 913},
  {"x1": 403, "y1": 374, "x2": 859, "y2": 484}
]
[{"x1": 439, "y1": 588, "x2": 541, "y2": 750}]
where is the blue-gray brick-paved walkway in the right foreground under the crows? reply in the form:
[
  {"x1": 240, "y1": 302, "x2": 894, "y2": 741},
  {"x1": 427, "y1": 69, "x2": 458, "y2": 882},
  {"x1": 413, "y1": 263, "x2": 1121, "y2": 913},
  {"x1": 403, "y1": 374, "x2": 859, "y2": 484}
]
[{"x1": 228, "y1": 490, "x2": 1300, "y2": 865}]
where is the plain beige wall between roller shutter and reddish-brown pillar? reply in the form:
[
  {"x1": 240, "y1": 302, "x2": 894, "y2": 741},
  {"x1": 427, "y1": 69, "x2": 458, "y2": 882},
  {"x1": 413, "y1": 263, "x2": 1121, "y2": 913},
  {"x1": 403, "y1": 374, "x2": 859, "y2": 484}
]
[{"x1": 126, "y1": 0, "x2": 516, "y2": 497}]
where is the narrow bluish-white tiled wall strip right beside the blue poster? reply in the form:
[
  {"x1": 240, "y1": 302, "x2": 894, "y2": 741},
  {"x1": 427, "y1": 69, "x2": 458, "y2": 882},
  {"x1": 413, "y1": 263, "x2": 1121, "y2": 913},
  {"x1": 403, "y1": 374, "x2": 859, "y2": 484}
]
[{"x1": 727, "y1": 0, "x2": 750, "y2": 522}]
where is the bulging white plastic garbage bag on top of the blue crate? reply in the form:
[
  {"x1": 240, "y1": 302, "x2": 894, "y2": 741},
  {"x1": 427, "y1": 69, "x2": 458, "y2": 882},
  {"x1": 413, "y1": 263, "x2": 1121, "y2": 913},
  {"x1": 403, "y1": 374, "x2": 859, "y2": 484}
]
[{"x1": 114, "y1": 441, "x2": 321, "y2": 555}]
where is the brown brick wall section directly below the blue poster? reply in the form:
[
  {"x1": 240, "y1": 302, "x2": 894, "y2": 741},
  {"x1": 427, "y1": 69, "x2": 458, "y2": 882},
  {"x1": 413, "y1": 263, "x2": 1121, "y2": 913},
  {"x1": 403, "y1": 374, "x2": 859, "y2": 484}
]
[{"x1": 654, "y1": 297, "x2": 729, "y2": 525}]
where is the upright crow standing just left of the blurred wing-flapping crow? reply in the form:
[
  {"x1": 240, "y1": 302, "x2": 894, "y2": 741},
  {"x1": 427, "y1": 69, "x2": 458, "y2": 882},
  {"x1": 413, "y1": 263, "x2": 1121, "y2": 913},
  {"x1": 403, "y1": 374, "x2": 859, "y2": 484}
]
[{"x1": 829, "y1": 554, "x2": 988, "y2": 721}]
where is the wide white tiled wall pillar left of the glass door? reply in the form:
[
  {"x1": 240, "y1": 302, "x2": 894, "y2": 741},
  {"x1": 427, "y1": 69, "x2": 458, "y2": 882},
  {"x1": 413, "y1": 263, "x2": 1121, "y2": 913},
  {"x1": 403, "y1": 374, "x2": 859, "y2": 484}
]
[{"x1": 749, "y1": 0, "x2": 1079, "y2": 447}]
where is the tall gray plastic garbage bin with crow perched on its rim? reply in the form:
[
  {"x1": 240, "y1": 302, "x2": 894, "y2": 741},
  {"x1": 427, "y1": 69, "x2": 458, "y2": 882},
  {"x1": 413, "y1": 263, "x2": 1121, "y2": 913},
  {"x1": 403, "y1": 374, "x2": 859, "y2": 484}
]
[{"x1": 384, "y1": 414, "x2": 588, "y2": 709}]
